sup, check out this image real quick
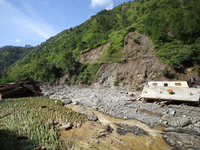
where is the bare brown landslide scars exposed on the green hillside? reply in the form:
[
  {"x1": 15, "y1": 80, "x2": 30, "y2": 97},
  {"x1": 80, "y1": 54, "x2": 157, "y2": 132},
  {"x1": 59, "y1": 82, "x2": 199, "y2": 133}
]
[{"x1": 74, "y1": 31, "x2": 198, "y2": 87}]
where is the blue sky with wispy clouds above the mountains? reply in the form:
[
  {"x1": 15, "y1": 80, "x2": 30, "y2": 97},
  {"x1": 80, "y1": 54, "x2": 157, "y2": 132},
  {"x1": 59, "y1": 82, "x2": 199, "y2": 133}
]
[{"x1": 0, "y1": 0, "x2": 132, "y2": 47}]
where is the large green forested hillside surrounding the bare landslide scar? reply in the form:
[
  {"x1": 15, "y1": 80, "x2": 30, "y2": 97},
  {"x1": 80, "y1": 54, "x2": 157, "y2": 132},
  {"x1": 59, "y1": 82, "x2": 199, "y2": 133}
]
[{"x1": 2, "y1": 0, "x2": 200, "y2": 84}]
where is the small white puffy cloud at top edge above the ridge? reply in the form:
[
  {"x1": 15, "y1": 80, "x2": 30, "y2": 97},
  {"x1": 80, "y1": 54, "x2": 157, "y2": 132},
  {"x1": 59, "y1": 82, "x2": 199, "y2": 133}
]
[{"x1": 91, "y1": 0, "x2": 114, "y2": 9}]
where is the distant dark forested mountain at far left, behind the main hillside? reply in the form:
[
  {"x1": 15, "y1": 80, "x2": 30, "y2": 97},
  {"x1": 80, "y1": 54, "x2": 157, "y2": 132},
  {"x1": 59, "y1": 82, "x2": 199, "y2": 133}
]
[{"x1": 0, "y1": 45, "x2": 32, "y2": 78}]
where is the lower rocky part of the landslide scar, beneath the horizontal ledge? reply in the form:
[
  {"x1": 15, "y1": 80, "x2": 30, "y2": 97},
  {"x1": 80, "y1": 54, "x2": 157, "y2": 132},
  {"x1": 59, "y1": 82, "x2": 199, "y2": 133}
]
[{"x1": 94, "y1": 55, "x2": 165, "y2": 87}]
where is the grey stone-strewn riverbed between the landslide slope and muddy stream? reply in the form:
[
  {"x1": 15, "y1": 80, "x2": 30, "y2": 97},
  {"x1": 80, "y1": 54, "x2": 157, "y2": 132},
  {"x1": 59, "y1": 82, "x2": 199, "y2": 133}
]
[{"x1": 42, "y1": 85, "x2": 200, "y2": 150}]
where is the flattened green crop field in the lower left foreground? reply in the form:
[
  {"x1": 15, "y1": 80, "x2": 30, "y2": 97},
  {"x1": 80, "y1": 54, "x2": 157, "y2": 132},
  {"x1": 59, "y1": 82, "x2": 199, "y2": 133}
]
[{"x1": 0, "y1": 97, "x2": 86, "y2": 150}]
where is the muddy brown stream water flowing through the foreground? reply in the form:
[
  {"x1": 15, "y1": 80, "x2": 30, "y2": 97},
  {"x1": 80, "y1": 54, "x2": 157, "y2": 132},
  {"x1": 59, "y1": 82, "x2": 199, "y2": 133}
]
[{"x1": 67, "y1": 105, "x2": 173, "y2": 150}]
